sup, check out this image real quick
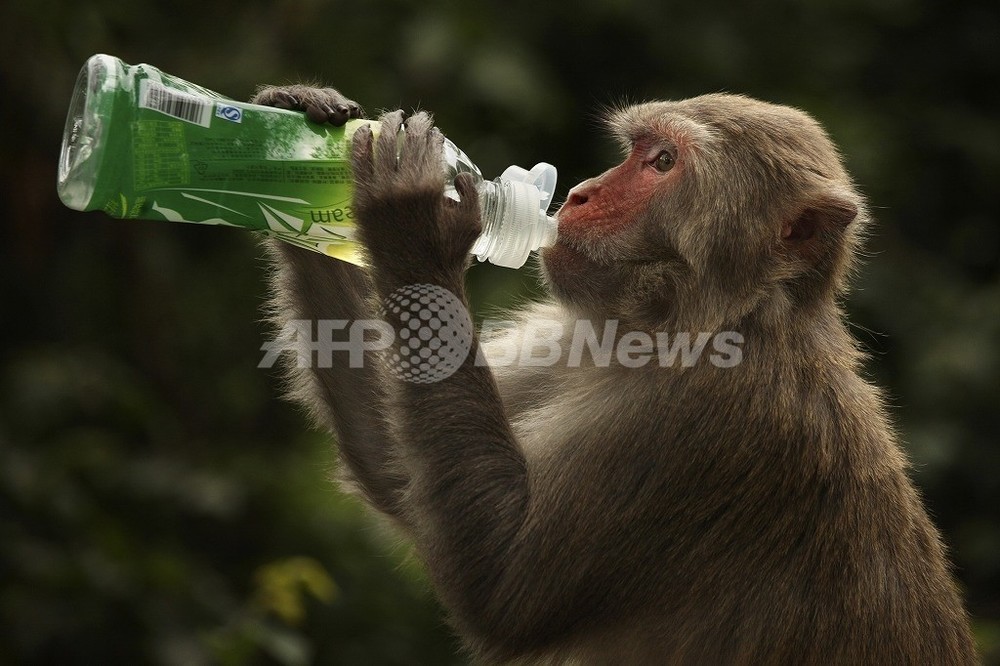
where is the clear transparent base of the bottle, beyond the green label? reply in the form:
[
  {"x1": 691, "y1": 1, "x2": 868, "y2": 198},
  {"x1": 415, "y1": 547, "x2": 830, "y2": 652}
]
[{"x1": 56, "y1": 54, "x2": 118, "y2": 210}]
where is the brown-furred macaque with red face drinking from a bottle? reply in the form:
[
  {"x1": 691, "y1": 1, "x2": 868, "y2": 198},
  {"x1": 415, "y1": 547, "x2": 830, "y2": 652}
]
[{"x1": 257, "y1": 89, "x2": 977, "y2": 665}]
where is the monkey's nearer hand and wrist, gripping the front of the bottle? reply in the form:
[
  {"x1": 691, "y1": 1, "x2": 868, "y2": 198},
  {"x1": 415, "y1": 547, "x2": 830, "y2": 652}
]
[{"x1": 351, "y1": 111, "x2": 481, "y2": 296}]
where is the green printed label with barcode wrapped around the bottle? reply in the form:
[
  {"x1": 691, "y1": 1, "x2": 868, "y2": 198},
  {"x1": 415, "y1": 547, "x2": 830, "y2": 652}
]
[{"x1": 87, "y1": 65, "x2": 370, "y2": 260}]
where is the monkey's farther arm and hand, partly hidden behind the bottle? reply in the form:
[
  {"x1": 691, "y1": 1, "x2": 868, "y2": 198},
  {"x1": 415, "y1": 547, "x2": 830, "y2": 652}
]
[{"x1": 252, "y1": 85, "x2": 407, "y2": 522}]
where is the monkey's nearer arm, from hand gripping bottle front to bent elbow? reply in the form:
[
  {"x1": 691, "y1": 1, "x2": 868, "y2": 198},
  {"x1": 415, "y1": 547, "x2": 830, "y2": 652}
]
[{"x1": 353, "y1": 112, "x2": 600, "y2": 649}]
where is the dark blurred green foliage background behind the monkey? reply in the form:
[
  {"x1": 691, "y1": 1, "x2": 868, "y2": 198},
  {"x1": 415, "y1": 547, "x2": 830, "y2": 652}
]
[{"x1": 0, "y1": 0, "x2": 1000, "y2": 665}]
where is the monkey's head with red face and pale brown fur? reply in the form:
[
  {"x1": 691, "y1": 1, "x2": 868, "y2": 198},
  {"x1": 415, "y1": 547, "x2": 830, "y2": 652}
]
[{"x1": 542, "y1": 94, "x2": 867, "y2": 330}]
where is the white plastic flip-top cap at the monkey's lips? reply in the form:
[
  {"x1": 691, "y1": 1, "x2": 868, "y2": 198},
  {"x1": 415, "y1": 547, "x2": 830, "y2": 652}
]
[{"x1": 479, "y1": 162, "x2": 558, "y2": 268}]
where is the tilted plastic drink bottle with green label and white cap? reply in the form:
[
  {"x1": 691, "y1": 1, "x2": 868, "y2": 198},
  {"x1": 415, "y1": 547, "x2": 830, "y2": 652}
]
[{"x1": 57, "y1": 54, "x2": 556, "y2": 268}]
